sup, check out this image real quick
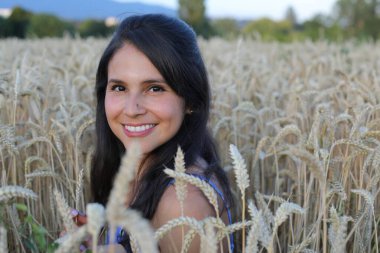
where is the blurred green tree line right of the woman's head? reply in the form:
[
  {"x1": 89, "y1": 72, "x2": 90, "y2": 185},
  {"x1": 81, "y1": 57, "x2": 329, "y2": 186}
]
[{"x1": 178, "y1": 0, "x2": 380, "y2": 42}]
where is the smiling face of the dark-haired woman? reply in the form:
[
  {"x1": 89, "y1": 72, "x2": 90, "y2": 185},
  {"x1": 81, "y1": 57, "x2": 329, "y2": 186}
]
[{"x1": 105, "y1": 43, "x2": 185, "y2": 155}]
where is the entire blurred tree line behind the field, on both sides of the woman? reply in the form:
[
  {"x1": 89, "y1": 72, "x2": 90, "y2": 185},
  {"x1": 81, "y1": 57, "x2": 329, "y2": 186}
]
[{"x1": 0, "y1": 0, "x2": 380, "y2": 42}]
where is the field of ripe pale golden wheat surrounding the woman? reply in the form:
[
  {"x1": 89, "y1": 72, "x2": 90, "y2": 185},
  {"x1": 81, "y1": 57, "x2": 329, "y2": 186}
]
[{"x1": 0, "y1": 38, "x2": 380, "y2": 253}]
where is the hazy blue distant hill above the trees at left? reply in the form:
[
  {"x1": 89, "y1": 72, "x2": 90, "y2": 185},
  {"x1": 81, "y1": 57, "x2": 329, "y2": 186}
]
[{"x1": 0, "y1": 0, "x2": 176, "y2": 21}]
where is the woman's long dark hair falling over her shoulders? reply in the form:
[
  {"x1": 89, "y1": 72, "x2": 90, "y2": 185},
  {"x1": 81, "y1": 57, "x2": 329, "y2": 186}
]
[{"x1": 91, "y1": 14, "x2": 231, "y2": 219}]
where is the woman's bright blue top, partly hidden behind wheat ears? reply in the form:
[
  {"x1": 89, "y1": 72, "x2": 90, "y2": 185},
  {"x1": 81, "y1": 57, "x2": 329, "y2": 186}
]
[{"x1": 105, "y1": 173, "x2": 235, "y2": 253}]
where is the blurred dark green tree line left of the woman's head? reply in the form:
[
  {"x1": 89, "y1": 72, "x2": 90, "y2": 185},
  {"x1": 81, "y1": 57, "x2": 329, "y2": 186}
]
[{"x1": 0, "y1": 7, "x2": 114, "y2": 38}]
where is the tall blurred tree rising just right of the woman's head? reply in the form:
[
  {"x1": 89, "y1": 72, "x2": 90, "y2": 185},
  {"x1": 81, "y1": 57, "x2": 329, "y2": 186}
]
[{"x1": 178, "y1": 0, "x2": 214, "y2": 38}]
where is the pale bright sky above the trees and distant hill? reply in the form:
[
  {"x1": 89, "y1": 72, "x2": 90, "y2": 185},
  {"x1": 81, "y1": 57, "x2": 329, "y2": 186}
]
[{"x1": 117, "y1": 0, "x2": 337, "y2": 21}]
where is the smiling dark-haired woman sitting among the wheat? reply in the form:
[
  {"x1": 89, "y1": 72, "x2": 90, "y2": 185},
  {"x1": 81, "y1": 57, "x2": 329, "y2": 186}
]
[{"x1": 91, "y1": 14, "x2": 231, "y2": 252}]
